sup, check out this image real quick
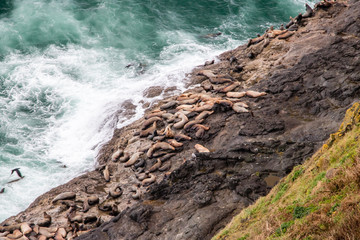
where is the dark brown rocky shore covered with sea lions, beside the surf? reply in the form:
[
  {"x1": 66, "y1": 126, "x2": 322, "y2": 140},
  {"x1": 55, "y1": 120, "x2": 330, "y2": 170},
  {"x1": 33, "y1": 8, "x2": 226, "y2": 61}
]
[{"x1": 0, "y1": 0, "x2": 360, "y2": 239}]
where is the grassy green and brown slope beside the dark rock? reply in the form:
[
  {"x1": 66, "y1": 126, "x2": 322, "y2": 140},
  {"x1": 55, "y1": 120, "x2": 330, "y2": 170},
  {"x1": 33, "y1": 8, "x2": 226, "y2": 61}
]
[{"x1": 213, "y1": 103, "x2": 360, "y2": 240}]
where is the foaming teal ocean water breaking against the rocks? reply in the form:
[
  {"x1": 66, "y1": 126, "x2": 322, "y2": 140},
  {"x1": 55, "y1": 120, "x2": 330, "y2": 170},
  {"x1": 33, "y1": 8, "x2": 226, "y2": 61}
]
[{"x1": 0, "y1": 0, "x2": 313, "y2": 222}]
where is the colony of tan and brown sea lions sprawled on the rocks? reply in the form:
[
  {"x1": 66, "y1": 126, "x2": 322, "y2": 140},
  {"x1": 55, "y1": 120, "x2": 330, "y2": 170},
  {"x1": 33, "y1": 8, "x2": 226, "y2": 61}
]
[{"x1": 0, "y1": 1, "x2": 334, "y2": 240}]
